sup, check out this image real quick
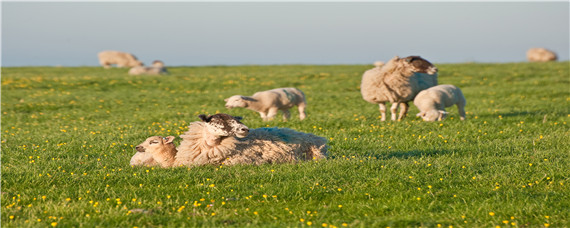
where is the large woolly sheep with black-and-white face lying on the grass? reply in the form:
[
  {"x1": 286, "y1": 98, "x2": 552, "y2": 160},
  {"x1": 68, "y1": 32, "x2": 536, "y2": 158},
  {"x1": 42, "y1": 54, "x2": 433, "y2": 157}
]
[{"x1": 174, "y1": 114, "x2": 327, "y2": 167}]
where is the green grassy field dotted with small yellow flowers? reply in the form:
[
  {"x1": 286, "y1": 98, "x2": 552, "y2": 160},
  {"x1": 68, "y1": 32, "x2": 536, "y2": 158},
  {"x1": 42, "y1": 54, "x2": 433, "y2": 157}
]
[{"x1": 1, "y1": 62, "x2": 570, "y2": 227}]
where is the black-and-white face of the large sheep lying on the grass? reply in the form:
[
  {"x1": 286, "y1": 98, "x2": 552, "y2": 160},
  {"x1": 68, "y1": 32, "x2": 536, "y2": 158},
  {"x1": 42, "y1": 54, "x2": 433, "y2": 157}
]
[{"x1": 199, "y1": 113, "x2": 249, "y2": 138}]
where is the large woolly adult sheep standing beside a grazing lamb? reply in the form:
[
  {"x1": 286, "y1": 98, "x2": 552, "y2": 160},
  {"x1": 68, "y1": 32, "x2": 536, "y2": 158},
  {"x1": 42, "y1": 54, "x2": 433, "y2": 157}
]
[{"x1": 360, "y1": 56, "x2": 438, "y2": 121}]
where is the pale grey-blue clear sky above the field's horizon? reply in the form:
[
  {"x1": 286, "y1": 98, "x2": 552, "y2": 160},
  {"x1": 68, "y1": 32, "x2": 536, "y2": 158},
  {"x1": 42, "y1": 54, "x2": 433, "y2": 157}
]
[{"x1": 1, "y1": 1, "x2": 570, "y2": 67}]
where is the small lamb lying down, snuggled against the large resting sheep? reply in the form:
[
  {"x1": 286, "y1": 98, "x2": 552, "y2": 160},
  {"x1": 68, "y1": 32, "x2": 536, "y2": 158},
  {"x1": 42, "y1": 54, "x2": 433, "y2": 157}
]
[{"x1": 130, "y1": 136, "x2": 177, "y2": 168}]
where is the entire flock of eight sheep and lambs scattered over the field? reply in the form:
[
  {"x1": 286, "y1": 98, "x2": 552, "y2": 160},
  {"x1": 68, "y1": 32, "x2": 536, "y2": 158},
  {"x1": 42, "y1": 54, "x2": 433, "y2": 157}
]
[{"x1": 98, "y1": 48, "x2": 557, "y2": 168}]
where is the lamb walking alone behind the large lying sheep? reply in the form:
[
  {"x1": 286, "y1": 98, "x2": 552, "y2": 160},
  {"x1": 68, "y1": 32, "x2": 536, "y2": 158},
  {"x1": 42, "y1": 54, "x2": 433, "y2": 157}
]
[{"x1": 224, "y1": 88, "x2": 307, "y2": 121}]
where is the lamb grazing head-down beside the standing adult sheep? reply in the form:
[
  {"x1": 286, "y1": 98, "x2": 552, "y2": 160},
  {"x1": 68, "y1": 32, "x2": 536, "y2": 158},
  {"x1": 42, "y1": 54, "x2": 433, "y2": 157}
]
[{"x1": 414, "y1": 85, "x2": 467, "y2": 121}]
